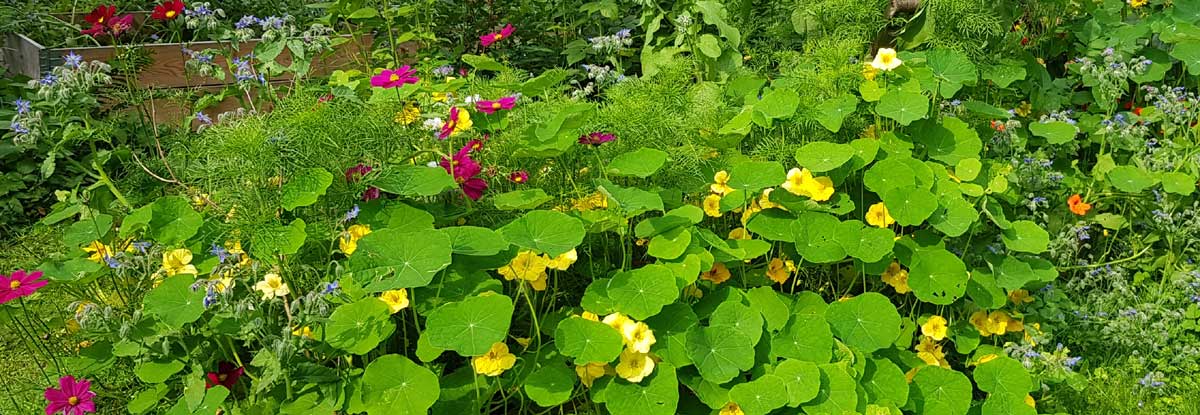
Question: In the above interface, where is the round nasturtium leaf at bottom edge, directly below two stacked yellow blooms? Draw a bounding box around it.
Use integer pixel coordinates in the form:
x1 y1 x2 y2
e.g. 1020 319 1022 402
910 366 972 415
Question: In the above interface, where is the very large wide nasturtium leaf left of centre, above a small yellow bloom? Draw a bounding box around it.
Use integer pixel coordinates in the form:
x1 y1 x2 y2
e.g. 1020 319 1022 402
348 228 454 293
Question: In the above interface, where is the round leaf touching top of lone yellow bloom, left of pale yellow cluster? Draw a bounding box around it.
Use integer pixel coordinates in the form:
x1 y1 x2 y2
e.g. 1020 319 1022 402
424 294 514 356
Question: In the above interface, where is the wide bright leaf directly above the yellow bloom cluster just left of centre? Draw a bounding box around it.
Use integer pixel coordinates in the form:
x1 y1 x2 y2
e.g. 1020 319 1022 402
496 210 583 257
